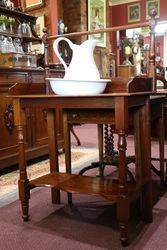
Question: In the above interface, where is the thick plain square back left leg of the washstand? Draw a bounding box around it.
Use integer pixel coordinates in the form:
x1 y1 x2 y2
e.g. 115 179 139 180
47 109 60 204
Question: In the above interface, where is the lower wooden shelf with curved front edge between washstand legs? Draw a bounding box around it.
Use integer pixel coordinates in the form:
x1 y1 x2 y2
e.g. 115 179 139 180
29 172 140 201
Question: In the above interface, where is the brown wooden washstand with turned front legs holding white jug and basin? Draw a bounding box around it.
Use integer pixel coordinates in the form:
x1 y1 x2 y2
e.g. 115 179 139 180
10 8 166 245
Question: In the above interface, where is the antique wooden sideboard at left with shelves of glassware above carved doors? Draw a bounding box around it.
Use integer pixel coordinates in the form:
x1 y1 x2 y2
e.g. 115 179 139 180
0 6 48 169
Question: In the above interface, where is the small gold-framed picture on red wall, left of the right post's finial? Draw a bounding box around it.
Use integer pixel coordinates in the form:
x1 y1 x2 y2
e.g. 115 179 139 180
128 3 140 23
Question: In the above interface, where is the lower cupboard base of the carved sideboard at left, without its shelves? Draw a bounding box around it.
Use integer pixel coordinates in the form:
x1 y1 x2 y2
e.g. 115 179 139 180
0 67 66 169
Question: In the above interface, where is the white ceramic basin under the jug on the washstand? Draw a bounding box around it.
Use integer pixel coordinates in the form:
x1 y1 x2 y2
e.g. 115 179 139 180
47 78 111 95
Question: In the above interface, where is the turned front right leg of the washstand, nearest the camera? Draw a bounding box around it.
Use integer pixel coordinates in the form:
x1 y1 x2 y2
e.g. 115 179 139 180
115 97 130 246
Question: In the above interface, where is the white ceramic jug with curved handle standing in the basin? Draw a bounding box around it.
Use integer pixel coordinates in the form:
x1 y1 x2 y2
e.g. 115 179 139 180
53 37 100 81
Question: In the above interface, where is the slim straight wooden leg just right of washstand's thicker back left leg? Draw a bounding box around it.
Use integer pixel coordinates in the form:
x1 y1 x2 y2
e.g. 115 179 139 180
63 111 72 204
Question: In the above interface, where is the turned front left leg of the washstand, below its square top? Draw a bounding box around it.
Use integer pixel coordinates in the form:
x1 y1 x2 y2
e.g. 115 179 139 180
17 125 30 221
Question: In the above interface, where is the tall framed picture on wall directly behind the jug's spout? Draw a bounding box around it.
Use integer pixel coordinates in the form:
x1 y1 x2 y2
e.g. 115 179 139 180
88 0 106 47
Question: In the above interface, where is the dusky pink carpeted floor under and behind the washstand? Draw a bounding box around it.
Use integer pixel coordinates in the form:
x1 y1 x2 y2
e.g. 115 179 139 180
0 125 167 250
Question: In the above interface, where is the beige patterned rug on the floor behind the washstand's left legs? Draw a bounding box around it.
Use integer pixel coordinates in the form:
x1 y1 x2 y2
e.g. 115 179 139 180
0 147 98 205
